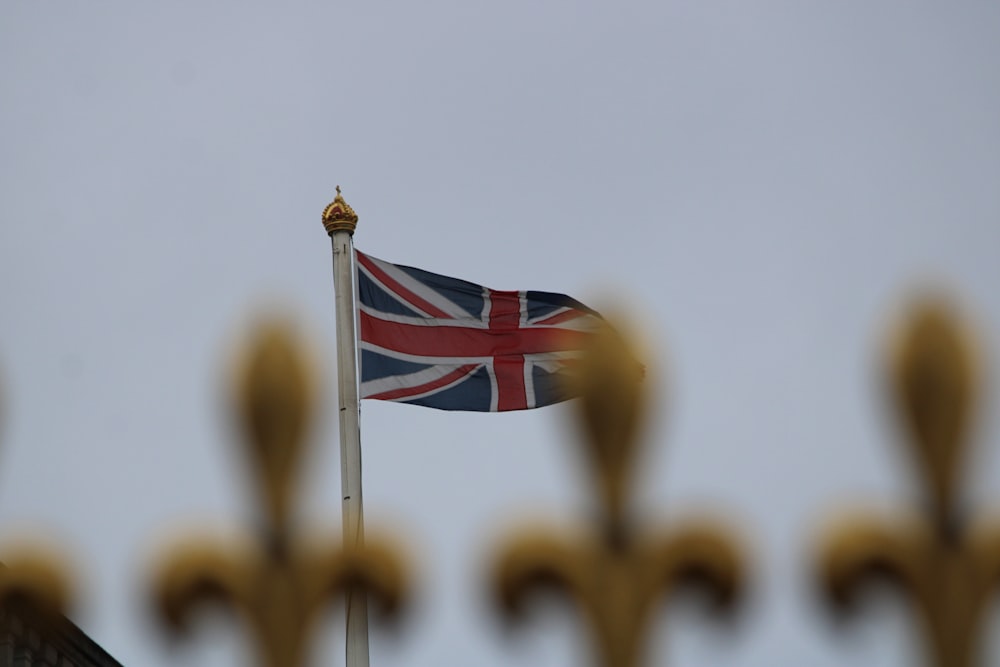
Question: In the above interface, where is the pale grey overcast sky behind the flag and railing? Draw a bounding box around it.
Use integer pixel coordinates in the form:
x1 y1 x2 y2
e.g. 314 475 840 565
0 0 1000 667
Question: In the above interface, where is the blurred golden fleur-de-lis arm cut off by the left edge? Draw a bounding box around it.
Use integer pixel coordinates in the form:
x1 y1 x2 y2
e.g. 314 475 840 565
0 384 72 623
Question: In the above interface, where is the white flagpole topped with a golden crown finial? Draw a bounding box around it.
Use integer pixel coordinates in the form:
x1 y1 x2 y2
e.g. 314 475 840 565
323 185 368 667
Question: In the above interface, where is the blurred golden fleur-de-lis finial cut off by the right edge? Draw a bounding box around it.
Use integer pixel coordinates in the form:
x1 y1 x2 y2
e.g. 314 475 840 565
818 299 1000 667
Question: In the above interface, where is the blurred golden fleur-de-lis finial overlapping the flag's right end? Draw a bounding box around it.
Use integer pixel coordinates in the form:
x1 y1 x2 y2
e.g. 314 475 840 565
492 318 745 667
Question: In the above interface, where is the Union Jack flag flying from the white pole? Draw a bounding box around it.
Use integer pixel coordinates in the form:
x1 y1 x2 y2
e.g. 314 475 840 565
355 251 600 412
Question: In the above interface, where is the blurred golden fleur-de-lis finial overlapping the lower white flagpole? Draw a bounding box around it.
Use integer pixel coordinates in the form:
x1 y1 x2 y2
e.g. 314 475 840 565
153 322 408 667
